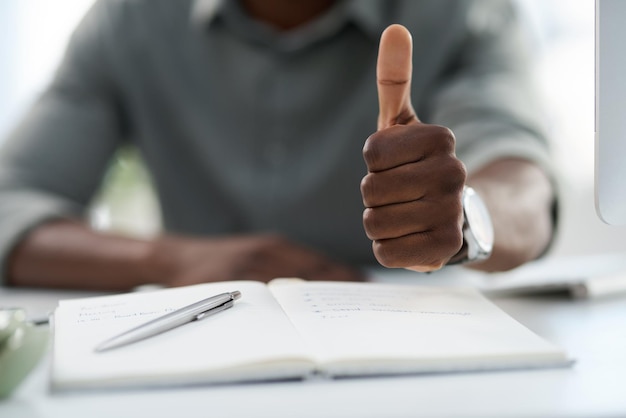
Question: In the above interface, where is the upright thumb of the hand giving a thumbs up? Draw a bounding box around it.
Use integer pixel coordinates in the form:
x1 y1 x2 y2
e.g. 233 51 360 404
376 25 419 130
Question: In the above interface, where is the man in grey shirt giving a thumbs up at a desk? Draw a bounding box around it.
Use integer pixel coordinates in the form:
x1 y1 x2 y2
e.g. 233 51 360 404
0 0 555 290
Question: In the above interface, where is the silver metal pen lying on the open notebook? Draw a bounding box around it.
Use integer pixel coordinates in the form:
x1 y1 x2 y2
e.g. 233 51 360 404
95 290 241 352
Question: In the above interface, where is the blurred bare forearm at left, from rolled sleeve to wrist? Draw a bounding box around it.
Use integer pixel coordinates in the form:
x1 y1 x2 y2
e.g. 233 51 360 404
7 221 159 291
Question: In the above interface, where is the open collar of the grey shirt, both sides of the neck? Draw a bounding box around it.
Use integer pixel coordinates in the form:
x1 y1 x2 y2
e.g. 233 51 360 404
190 0 387 41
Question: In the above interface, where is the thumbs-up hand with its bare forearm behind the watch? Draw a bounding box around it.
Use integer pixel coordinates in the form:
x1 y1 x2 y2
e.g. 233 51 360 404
361 25 553 271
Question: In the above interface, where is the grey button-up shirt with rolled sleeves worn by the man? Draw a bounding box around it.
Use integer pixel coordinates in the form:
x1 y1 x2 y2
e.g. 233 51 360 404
0 0 550 280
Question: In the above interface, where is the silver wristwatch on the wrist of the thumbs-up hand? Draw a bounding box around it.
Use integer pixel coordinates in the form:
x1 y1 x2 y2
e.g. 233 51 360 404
448 186 493 264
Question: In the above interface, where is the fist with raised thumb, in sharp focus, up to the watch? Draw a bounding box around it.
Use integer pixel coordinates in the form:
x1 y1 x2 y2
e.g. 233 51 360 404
361 25 466 271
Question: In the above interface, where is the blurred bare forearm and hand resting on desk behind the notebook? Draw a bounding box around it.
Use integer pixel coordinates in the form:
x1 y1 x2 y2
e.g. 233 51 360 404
8 221 364 291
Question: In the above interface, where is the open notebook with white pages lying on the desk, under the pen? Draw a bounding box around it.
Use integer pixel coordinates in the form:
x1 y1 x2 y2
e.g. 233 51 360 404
51 279 571 389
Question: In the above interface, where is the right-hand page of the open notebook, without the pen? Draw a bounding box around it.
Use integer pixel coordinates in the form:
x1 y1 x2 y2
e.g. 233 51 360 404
270 280 566 374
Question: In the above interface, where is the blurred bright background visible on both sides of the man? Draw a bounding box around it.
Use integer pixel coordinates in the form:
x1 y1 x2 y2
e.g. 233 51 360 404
0 0 626 255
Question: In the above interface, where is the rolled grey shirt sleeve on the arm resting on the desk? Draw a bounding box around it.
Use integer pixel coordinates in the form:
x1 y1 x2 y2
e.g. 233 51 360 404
0 1 124 282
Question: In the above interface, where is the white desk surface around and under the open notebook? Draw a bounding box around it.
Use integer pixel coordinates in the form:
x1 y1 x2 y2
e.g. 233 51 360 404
0 270 626 418
